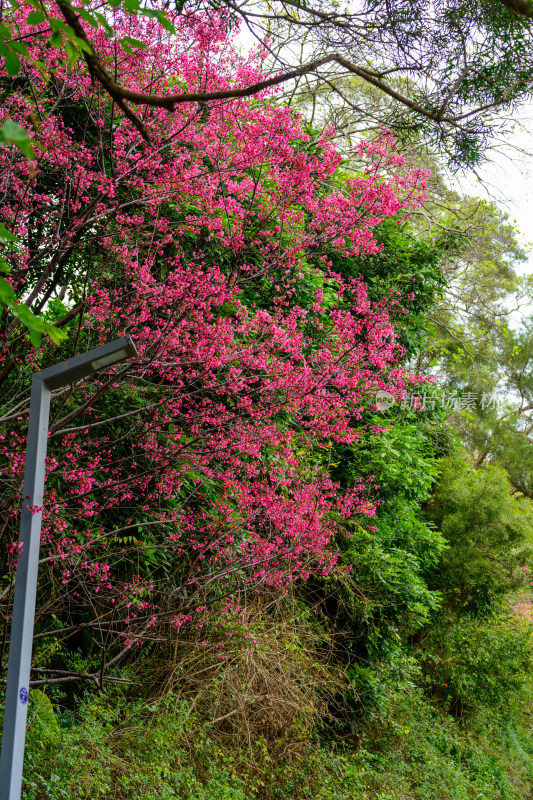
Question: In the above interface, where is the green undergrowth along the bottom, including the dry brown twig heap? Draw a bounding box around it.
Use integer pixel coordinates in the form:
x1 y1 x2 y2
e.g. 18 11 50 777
23 610 533 800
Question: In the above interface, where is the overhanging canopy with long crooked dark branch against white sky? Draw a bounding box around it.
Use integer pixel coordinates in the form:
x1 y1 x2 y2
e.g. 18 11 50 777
1 0 533 165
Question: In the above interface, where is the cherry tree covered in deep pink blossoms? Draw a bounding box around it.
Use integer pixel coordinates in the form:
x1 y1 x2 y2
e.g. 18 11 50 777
0 5 425 681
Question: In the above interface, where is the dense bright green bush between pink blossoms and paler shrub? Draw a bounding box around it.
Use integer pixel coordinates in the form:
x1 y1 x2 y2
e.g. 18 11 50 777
301 412 444 724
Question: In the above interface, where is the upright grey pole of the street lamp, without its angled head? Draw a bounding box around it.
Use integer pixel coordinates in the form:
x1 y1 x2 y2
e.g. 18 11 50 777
0 373 50 800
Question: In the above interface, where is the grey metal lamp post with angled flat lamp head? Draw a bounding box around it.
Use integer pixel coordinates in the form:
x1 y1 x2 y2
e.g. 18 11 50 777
0 336 137 800
